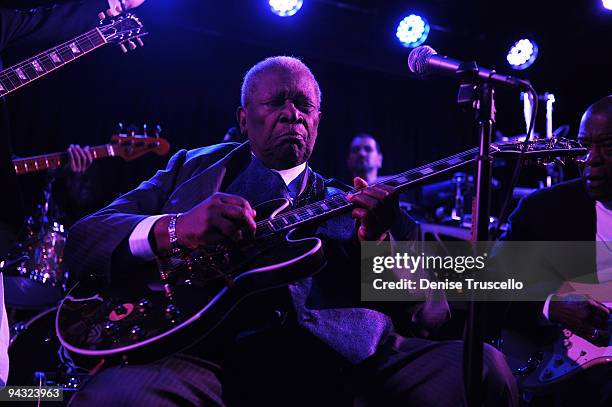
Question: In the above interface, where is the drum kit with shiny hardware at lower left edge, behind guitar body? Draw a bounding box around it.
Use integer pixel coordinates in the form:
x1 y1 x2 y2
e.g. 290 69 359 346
0 180 86 390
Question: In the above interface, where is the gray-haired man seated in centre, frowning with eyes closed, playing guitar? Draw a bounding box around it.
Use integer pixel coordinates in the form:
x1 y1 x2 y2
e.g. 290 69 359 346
66 57 516 406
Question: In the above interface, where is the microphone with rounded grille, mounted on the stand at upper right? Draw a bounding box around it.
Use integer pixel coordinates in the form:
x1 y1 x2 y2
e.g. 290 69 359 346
408 45 531 89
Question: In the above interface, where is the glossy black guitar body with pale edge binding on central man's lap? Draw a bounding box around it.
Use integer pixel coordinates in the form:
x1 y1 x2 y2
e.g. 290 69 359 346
56 200 325 368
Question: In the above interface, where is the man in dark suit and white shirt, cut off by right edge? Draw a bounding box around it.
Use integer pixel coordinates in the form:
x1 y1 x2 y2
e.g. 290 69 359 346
503 96 612 406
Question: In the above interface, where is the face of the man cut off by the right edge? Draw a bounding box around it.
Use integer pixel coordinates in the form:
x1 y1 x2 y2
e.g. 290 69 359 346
578 112 612 202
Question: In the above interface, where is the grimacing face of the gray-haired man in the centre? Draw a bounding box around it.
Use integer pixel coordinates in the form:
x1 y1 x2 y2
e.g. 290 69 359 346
238 68 321 170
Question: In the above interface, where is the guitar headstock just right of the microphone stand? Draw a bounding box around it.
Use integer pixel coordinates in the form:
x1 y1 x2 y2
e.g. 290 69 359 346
491 137 587 163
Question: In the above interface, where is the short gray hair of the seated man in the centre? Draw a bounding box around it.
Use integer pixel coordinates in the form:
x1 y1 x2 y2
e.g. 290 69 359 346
240 56 321 108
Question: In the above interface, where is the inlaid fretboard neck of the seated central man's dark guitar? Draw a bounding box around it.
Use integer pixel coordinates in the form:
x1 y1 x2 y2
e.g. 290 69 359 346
256 148 480 238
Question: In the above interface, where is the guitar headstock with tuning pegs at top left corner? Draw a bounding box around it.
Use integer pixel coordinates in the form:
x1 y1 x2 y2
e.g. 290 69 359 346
98 13 148 52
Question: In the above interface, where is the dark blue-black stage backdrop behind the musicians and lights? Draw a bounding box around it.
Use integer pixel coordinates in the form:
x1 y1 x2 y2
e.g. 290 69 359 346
4 0 612 220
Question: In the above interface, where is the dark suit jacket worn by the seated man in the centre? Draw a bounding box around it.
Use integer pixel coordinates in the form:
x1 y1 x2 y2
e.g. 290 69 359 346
65 143 447 363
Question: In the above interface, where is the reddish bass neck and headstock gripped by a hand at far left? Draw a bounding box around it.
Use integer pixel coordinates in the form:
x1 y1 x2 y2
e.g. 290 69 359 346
13 134 170 175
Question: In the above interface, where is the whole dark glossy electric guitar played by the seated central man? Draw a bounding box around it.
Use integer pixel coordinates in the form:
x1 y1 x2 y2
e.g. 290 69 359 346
56 139 586 366
